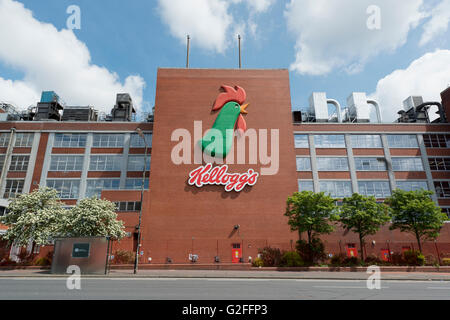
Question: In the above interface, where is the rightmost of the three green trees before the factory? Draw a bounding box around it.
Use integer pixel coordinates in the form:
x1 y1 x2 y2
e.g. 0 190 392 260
386 189 447 252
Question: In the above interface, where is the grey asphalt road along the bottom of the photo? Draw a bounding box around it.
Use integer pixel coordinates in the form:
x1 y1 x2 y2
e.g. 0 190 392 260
0 278 450 301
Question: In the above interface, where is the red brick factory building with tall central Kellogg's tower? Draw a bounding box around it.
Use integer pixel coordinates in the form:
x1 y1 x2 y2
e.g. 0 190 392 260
0 69 450 263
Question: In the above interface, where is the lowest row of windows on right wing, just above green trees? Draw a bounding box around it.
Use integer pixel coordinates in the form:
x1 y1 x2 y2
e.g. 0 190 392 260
298 180 428 198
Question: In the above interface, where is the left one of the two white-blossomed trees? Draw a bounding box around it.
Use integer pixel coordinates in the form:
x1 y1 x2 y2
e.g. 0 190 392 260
0 187 66 246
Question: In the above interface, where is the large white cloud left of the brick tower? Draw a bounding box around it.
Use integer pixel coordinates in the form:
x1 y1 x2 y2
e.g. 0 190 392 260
0 0 145 112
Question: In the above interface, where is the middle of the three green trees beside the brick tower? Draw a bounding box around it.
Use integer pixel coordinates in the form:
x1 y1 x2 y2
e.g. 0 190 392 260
339 193 390 261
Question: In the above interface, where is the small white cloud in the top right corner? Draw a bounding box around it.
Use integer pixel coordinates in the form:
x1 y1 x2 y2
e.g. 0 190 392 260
419 0 450 46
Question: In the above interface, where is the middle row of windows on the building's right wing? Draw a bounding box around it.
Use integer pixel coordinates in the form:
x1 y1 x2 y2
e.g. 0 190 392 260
297 157 424 171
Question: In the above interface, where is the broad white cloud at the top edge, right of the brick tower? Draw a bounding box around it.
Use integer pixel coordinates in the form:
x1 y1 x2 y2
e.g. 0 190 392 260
285 0 424 75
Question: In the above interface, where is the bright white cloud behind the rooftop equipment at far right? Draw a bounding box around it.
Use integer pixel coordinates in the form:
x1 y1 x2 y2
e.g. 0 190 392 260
371 50 450 122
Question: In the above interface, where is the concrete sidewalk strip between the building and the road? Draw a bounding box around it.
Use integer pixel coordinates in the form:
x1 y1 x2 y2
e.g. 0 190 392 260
0 270 450 281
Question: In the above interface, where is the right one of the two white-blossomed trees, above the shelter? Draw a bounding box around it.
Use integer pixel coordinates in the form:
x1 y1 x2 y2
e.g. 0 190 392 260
62 197 126 239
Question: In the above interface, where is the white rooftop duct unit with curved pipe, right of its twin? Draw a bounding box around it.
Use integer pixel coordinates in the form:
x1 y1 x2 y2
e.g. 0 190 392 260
347 92 381 123
